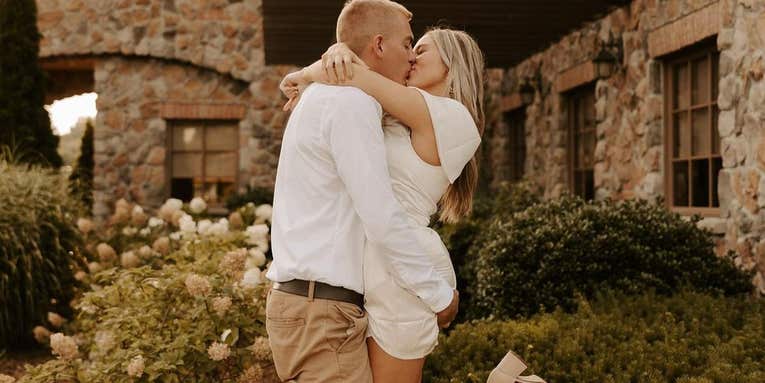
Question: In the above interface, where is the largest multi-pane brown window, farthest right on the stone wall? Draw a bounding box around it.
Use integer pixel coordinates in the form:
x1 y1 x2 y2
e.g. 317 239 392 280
665 45 722 214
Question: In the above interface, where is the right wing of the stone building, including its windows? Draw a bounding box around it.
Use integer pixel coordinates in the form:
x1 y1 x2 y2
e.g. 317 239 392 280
485 0 765 292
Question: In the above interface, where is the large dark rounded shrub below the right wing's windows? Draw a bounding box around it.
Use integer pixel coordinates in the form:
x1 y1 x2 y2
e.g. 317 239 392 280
468 196 752 318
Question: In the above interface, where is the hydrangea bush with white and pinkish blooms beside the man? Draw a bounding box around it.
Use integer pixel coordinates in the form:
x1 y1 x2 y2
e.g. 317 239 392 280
21 199 273 383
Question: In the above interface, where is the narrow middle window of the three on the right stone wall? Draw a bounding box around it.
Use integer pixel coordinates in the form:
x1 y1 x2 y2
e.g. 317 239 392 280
568 85 596 200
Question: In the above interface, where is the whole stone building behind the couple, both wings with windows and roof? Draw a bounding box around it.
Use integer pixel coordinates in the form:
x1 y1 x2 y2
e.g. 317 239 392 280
37 0 765 290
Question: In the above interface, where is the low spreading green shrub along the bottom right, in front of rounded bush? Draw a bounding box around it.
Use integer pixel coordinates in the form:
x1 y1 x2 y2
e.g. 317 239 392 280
424 292 765 383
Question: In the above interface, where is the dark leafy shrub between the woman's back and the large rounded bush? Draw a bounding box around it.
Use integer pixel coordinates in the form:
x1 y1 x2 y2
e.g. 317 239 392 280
435 181 541 323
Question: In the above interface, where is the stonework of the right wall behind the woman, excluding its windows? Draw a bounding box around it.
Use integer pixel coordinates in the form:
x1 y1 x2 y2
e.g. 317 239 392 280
484 0 765 291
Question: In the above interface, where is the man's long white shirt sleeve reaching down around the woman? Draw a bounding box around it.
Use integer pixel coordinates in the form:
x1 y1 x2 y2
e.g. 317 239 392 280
324 88 454 312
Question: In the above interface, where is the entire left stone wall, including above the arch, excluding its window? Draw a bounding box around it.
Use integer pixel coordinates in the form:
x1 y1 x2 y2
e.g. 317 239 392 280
37 0 294 218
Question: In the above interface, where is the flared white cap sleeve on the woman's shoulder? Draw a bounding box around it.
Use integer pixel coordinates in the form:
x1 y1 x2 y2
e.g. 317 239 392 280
415 88 481 183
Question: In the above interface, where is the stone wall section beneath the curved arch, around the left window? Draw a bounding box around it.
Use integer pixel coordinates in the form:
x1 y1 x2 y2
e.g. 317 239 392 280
94 57 287 216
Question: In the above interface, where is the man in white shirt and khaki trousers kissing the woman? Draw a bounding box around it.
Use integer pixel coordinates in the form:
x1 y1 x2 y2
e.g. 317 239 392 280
266 0 458 383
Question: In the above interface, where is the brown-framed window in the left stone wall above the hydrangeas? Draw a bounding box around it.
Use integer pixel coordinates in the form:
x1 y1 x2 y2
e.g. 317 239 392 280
168 121 239 208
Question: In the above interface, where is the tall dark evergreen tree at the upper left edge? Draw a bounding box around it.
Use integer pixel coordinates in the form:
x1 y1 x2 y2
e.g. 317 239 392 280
0 0 62 167
